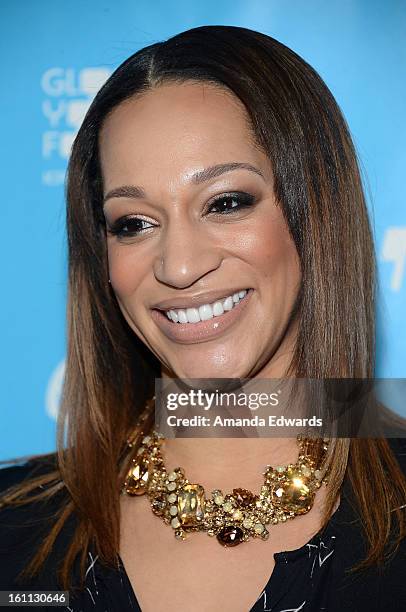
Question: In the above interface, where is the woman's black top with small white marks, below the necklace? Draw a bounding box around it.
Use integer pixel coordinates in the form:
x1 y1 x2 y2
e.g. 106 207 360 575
0 439 406 612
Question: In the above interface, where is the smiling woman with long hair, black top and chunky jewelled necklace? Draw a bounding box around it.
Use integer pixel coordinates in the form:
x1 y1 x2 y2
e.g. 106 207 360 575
0 26 406 612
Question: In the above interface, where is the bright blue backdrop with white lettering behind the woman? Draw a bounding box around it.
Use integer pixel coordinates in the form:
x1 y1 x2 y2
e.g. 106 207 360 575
0 0 406 460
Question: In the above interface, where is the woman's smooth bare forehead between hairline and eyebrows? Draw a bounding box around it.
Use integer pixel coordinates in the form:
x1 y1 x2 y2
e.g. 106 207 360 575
100 82 267 183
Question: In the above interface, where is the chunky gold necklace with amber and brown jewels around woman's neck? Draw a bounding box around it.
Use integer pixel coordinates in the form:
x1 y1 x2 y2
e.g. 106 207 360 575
122 400 329 546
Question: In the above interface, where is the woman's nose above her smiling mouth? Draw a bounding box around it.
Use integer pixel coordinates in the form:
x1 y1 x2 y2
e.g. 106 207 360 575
153 221 223 289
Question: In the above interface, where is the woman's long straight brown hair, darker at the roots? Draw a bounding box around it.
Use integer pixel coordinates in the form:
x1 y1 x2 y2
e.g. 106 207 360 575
3 26 406 588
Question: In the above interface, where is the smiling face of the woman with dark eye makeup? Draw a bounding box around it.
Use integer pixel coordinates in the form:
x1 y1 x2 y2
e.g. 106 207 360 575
100 83 300 378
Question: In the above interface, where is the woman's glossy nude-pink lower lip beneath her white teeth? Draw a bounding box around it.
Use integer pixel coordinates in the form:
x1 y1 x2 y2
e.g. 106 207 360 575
151 289 253 344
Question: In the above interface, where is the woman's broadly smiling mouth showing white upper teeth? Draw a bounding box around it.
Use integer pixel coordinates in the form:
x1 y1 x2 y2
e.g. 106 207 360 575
151 289 254 344
